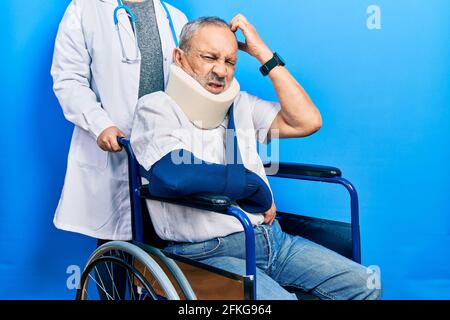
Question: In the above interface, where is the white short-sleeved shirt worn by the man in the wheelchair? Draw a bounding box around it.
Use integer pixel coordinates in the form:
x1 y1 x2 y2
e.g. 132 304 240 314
131 92 280 242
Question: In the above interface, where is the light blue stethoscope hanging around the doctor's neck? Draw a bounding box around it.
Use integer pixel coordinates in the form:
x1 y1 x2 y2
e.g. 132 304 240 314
114 0 178 64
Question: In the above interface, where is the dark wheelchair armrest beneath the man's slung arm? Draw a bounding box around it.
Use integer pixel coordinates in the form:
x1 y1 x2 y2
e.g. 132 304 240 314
139 185 231 213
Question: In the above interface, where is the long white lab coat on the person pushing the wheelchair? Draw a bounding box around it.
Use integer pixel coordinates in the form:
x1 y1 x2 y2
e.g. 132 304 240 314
51 0 187 240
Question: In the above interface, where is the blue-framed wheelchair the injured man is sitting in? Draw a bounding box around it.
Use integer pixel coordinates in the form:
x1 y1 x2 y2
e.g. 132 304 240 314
76 138 361 300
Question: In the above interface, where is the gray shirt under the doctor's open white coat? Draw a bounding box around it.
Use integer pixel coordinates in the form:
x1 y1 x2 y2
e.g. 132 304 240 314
125 0 164 98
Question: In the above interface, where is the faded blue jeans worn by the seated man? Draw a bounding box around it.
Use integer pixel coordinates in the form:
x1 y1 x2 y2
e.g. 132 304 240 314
165 220 381 300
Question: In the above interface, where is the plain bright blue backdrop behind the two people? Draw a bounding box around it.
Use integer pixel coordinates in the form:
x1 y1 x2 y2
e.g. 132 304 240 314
0 0 450 299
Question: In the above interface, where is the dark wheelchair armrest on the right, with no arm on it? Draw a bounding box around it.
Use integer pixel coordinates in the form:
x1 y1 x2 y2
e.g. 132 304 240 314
264 162 342 178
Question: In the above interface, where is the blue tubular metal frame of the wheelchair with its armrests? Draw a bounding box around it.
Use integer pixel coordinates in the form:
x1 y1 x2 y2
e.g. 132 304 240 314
77 138 361 300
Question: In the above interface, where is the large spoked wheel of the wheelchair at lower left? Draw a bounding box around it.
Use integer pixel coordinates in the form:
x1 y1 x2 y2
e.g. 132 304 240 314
77 241 180 300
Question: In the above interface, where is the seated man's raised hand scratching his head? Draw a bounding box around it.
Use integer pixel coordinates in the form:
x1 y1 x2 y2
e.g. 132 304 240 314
230 14 273 64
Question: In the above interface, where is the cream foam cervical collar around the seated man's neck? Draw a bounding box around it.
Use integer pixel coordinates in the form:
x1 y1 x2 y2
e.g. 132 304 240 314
166 64 240 129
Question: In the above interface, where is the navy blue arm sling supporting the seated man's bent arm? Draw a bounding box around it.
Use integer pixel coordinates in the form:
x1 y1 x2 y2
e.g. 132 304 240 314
140 106 273 213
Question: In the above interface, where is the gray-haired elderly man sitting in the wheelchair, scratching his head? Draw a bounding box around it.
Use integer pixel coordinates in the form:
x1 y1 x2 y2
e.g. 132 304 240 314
131 15 380 299
